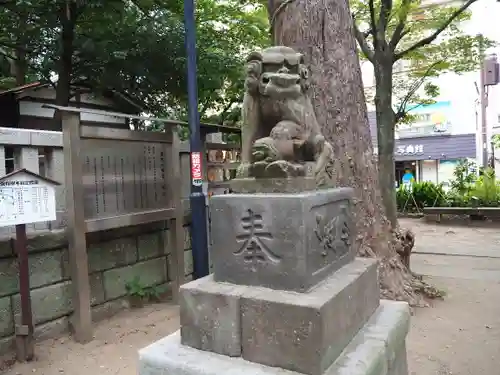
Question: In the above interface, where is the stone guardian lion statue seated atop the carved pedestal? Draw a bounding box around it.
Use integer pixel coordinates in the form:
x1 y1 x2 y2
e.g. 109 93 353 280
239 46 333 185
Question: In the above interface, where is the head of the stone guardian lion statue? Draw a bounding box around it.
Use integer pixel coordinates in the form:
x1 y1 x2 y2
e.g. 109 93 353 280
245 46 309 99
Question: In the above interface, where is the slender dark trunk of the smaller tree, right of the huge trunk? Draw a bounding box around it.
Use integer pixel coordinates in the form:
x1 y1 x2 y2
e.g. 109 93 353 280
375 61 398 228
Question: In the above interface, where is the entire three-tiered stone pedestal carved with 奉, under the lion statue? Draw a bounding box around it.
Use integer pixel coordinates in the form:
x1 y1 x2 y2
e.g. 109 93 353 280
139 189 409 375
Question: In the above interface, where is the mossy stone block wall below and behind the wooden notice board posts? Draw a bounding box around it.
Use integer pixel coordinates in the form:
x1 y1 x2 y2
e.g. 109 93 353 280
0 223 193 354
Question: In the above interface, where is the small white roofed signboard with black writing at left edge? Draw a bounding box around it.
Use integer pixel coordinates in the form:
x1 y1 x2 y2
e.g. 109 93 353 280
0 169 59 227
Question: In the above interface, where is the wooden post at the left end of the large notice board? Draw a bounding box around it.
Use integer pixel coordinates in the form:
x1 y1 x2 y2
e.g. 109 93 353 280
62 112 93 343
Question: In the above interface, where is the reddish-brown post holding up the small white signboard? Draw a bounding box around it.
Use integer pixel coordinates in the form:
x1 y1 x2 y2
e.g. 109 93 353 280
15 224 34 361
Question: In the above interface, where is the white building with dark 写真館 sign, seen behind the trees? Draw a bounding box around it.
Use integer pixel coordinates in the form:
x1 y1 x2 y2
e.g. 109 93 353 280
361 0 500 187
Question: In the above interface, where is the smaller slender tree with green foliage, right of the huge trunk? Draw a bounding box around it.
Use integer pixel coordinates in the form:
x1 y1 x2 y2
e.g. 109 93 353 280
351 0 491 225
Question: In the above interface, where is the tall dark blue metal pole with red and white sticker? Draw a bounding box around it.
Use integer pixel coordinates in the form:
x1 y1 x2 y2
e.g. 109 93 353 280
184 0 209 279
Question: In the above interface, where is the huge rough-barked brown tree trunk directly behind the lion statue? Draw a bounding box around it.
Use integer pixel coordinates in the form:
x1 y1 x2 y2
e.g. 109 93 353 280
268 0 428 304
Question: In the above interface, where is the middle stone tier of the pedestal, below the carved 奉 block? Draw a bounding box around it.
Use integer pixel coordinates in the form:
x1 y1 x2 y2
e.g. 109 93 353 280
180 258 380 375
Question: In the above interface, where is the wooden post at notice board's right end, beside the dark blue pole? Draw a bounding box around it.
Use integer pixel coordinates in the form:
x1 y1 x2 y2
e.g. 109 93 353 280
169 131 184 302
